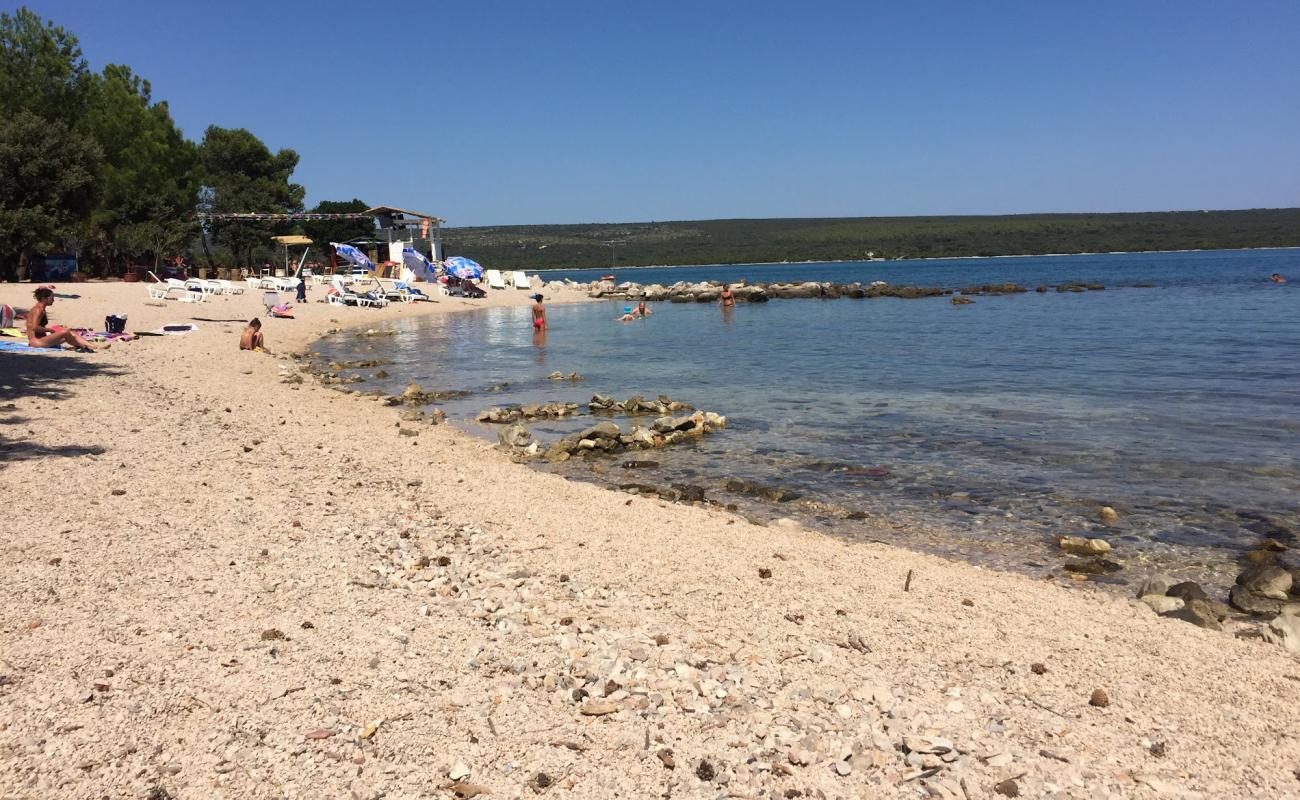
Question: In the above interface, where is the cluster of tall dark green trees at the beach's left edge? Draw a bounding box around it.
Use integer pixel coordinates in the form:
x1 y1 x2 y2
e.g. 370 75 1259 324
0 8 304 278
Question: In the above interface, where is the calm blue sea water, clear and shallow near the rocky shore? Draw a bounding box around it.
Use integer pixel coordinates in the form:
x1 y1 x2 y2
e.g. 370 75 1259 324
320 250 1300 579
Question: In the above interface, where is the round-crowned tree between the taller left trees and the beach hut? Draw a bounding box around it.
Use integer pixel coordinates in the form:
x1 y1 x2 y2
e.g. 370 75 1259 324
199 125 306 265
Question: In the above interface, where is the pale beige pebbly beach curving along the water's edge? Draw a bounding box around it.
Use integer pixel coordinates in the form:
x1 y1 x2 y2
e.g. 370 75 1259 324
0 282 1300 800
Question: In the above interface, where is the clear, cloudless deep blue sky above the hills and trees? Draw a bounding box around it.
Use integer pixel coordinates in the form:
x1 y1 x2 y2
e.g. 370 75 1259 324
20 0 1300 225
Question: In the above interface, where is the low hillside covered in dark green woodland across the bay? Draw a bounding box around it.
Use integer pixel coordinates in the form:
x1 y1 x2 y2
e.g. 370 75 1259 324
443 208 1300 271
